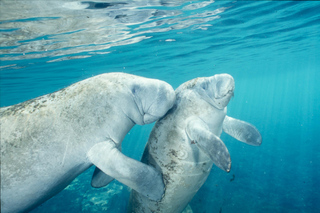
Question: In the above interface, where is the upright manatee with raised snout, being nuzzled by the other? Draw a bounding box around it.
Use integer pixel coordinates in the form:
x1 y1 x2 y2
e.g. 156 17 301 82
128 74 262 213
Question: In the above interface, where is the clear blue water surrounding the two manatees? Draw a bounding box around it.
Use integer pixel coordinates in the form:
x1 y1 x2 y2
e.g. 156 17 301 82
0 1 320 213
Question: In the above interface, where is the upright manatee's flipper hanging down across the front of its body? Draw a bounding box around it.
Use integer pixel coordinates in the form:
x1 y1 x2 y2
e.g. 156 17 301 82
186 119 231 172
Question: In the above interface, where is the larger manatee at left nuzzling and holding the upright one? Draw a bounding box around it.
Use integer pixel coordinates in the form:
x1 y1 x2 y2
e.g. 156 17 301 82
0 73 175 213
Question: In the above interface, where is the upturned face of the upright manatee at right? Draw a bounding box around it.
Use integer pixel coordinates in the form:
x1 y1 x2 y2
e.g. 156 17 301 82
195 74 235 109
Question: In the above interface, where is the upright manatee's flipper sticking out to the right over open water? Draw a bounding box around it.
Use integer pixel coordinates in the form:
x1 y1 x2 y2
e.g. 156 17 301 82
222 116 262 146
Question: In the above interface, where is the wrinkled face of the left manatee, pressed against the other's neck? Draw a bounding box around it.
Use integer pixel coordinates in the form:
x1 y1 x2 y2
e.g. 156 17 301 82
131 79 176 125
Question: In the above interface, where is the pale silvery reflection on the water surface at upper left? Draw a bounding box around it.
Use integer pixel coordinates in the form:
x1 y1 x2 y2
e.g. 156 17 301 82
0 1 226 62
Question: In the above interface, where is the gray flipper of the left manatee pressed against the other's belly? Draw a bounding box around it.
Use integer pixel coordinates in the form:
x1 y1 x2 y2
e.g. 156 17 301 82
87 140 164 200
